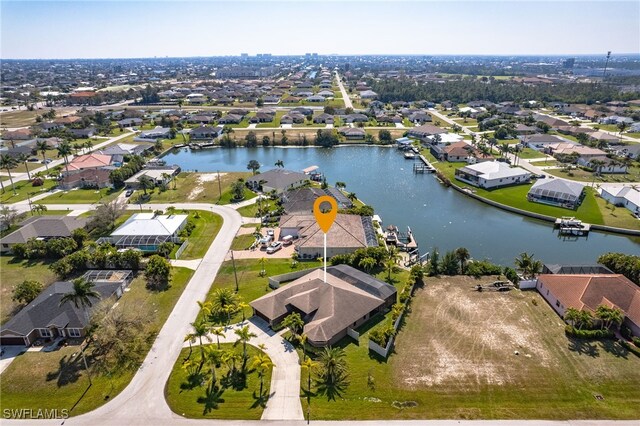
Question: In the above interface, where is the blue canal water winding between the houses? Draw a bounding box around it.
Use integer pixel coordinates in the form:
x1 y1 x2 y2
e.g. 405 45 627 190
164 146 640 265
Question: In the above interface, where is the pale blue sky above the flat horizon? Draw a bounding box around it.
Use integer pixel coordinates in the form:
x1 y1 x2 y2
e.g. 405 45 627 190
0 0 640 58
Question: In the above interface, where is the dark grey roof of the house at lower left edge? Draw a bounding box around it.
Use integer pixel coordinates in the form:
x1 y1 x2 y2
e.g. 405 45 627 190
0 281 122 336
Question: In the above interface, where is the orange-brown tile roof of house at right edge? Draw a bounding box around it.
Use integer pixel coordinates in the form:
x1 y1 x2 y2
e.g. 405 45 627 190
536 274 640 336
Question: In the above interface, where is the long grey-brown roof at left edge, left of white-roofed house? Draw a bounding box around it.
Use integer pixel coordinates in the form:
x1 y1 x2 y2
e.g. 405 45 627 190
0 216 89 244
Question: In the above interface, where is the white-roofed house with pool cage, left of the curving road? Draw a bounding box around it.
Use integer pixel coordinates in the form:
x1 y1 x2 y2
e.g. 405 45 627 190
97 213 189 253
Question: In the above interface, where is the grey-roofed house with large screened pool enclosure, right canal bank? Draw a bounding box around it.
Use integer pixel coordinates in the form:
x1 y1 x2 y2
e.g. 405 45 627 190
527 178 585 209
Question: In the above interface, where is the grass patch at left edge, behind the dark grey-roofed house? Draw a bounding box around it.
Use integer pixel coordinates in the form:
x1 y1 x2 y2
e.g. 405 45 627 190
0 256 56 324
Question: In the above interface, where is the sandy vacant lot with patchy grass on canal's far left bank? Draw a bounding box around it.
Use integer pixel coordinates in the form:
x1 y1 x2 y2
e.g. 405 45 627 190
140 172 255 204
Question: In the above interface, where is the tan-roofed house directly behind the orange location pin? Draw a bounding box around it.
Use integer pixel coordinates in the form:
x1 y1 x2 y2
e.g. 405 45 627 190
280 213 378 259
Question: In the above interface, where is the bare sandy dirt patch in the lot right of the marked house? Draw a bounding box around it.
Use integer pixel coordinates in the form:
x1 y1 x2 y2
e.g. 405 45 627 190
396 277 552 390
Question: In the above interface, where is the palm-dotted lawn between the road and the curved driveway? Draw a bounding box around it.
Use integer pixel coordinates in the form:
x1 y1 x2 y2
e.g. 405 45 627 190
165 343 271 420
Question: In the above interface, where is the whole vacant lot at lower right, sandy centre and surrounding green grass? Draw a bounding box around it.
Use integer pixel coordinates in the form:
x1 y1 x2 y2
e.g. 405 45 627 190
303 277 640 420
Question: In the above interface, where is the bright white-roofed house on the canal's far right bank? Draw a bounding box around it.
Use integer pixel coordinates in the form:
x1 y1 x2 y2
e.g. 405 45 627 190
455 161 531 189
